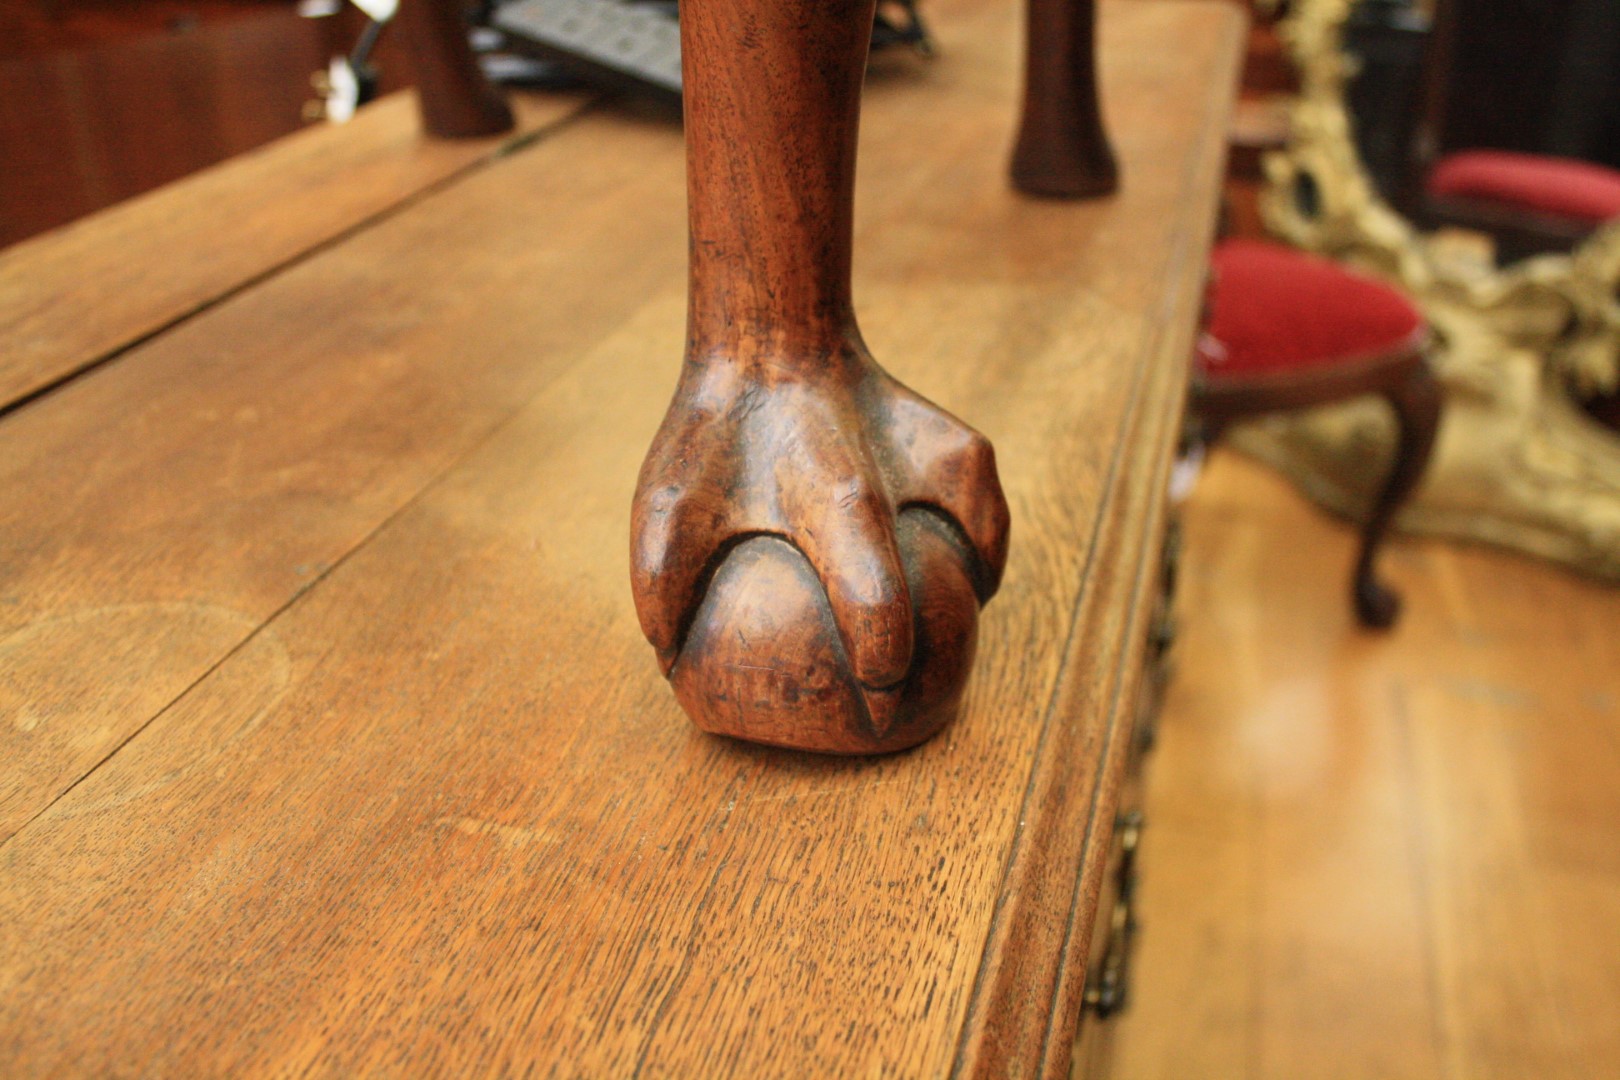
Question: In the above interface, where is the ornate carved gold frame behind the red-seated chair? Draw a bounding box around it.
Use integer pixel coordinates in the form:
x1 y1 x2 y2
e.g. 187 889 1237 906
1233 0 1620 580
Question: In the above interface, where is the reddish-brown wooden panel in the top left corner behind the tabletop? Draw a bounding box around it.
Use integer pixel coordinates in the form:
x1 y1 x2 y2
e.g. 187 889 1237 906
0 7 359 247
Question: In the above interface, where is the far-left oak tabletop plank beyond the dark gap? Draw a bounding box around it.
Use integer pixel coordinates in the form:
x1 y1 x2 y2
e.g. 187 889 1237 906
0 85 586 408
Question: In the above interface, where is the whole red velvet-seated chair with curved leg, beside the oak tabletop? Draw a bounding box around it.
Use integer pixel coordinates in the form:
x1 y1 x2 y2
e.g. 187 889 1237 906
1192 240 1440 628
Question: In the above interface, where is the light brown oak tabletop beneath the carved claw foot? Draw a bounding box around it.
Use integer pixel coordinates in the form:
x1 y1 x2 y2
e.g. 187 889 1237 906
0 0 1241 1077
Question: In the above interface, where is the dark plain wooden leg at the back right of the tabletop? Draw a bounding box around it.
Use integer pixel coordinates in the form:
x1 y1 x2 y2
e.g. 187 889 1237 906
1013 0 1119 199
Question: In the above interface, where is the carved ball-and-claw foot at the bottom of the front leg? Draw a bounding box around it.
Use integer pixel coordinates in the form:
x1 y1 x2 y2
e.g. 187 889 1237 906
632 334 1008 753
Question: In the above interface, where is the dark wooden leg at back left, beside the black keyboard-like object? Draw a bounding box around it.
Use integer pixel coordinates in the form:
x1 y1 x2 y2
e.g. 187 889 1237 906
397 0 512 139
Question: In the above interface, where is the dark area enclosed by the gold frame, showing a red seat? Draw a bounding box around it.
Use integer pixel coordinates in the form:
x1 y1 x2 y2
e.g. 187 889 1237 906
1343 0 1620 266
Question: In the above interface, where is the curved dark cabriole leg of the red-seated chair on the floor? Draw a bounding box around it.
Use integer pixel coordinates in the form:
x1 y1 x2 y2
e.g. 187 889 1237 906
1351 361 1440 630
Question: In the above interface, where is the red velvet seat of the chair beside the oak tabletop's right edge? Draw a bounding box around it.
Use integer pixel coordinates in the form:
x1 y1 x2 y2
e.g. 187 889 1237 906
1197 240 1424 381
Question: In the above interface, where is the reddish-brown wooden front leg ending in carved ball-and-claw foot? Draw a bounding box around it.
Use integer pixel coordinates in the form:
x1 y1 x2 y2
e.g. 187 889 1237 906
632 0 1008 753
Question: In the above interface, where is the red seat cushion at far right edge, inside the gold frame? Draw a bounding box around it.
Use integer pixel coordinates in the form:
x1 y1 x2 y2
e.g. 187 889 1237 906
1427 151 1620 225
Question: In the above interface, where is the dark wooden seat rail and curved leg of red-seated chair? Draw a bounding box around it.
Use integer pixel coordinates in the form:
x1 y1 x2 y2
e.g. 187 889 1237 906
1192 329 1440 630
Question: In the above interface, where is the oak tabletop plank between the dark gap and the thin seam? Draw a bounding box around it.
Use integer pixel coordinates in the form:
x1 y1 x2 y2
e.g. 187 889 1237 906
0 105 682 836
